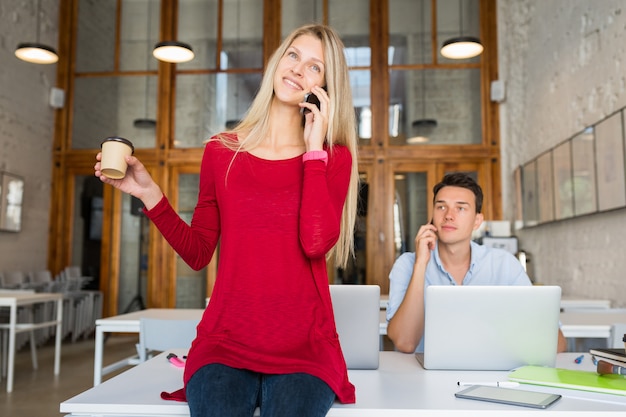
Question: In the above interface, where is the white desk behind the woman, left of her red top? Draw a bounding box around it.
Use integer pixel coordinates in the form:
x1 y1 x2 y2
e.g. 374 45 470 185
93 308 204 386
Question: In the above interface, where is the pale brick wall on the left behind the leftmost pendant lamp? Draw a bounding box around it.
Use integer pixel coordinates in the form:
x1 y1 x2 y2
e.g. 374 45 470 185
0 0 58 270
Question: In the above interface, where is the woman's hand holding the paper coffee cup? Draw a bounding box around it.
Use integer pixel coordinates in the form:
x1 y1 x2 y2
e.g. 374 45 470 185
94 152 163 210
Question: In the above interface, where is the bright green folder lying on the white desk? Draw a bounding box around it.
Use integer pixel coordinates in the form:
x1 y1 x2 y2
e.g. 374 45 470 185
509 366 626 395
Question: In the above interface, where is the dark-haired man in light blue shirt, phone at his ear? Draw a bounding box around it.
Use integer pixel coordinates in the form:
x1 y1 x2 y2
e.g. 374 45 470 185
387 172 567 353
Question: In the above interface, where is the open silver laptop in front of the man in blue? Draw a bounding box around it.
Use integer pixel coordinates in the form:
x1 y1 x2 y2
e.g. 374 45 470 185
416 285 561 370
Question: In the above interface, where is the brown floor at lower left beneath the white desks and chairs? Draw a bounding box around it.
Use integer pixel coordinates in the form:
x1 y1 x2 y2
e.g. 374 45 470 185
0 334 138 417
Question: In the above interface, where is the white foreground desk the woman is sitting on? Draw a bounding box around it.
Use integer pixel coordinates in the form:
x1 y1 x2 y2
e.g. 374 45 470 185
60 349 626 417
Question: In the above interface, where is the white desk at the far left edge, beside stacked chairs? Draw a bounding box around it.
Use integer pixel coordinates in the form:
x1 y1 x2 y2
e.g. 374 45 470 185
0 291 63 392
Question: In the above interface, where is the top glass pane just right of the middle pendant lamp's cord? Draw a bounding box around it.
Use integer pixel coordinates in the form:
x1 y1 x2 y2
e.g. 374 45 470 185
176 0 218 70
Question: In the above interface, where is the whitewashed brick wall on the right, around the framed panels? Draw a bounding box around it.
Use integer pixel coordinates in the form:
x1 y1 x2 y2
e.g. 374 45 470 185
498 0 626 307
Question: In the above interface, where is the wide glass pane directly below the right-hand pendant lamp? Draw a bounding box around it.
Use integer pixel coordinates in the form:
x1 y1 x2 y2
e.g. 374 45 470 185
389 69 482 145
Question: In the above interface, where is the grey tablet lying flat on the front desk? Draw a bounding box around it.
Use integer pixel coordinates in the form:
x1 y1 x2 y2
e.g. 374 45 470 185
454 385 561 408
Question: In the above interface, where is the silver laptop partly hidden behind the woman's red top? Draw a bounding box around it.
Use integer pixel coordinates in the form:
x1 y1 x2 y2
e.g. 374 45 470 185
330 284 380 369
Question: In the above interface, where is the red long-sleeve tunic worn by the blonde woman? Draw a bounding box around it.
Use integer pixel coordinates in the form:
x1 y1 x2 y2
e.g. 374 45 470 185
146 139 355 403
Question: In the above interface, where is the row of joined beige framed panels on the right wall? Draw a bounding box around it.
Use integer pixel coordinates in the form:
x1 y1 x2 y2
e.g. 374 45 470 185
515 103 626 227
